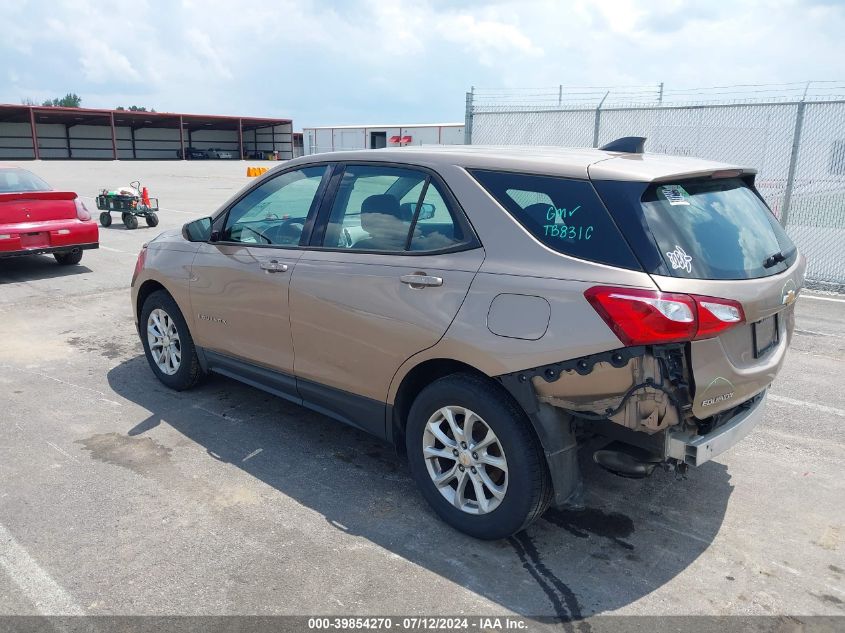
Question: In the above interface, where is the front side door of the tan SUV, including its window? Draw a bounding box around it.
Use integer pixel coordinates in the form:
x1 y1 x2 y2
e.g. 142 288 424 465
190 165 328 386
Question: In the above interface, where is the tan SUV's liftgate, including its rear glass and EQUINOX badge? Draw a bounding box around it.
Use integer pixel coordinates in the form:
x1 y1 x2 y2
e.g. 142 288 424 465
597 177 805 418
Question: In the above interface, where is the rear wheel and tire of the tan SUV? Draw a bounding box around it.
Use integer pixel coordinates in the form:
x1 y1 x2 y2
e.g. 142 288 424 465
405 374 553 540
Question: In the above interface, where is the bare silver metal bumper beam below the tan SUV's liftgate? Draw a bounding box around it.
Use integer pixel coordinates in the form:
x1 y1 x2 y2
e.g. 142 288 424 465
666 392 766 466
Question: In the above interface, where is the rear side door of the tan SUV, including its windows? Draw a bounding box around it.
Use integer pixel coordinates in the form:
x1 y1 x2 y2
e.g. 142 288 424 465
290 165 484 435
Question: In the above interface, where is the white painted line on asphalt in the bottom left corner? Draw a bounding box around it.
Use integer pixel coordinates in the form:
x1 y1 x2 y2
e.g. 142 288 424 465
0 524 85 615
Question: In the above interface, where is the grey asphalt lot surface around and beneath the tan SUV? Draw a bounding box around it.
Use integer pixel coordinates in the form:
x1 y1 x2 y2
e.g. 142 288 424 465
0 161 845 616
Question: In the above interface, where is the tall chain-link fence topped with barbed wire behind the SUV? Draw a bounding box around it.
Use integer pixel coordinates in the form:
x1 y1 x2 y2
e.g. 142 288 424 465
465 82 845 292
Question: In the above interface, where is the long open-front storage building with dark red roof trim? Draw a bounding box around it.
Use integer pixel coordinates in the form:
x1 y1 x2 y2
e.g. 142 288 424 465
0 105 293 160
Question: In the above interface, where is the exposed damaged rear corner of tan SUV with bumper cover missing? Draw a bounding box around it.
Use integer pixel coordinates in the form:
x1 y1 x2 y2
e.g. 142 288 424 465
499 345 766 498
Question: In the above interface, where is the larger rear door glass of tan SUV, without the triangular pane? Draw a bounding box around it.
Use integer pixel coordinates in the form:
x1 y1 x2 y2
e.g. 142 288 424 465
323 165 427 252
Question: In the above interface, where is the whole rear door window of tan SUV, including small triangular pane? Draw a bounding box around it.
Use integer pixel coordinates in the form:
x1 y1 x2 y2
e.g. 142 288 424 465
323 165 466 253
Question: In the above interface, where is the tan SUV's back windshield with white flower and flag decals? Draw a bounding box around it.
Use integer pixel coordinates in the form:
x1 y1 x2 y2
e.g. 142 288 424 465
642 178 796 279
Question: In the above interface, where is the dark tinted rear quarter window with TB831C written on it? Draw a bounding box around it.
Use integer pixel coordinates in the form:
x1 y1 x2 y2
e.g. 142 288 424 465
470 170 641 270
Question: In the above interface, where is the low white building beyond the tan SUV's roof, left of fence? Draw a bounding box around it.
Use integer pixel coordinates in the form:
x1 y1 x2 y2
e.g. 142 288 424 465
302 123 464 154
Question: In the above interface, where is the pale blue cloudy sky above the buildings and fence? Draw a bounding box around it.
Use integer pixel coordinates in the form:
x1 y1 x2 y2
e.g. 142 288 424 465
0 0 845 129
